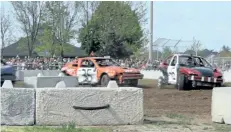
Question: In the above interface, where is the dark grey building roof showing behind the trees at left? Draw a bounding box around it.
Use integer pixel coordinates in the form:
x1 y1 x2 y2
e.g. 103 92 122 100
1 39 86 58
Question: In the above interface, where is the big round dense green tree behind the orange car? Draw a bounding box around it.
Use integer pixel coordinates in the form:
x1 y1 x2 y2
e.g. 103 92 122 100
78 1 143 58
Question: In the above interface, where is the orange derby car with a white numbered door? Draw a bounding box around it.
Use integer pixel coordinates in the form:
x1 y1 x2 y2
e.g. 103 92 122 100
61 57 143 87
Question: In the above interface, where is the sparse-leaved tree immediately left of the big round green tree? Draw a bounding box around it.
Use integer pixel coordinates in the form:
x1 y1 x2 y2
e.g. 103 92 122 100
41 1 80 56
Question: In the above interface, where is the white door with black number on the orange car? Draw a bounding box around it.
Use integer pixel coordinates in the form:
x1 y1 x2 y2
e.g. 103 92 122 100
77 59 98 84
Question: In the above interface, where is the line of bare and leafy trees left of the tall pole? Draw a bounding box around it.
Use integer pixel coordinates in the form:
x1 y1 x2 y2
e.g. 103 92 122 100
1 1 146 58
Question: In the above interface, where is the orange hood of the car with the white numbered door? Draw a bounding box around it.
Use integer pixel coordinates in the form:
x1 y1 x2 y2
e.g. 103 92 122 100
104 66 140 73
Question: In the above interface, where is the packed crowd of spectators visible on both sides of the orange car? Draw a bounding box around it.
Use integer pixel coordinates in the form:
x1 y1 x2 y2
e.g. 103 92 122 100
3 57 161 70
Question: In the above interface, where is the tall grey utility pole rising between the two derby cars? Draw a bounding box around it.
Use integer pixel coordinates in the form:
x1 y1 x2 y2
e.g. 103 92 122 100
149 1 152 62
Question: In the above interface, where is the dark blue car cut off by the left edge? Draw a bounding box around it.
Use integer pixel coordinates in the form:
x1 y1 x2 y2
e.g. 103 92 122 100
1 60 16 86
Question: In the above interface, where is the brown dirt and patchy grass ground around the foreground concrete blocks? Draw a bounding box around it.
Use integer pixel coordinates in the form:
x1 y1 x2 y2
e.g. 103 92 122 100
2 79 231 132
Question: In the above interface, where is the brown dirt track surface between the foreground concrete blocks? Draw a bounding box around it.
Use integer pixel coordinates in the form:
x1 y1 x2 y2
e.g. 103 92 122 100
139 80 212 122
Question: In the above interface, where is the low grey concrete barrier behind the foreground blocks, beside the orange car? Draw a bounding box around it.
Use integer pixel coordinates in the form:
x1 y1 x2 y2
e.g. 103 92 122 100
24 76 78 88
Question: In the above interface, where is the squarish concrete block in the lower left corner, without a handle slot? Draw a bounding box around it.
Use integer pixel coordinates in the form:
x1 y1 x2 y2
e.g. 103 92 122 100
1 88 35 125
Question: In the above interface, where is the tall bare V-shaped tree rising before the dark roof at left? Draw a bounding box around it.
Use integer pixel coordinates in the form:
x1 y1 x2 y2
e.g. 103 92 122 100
11 1 44 56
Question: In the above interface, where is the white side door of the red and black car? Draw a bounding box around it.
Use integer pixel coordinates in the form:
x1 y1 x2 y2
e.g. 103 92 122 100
168 56 177 84
